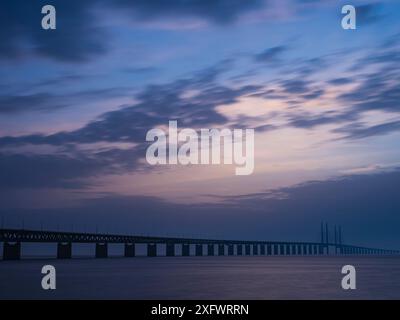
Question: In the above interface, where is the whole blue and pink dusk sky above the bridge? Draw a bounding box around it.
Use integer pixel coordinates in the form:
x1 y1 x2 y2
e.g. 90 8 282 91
0 0 400 248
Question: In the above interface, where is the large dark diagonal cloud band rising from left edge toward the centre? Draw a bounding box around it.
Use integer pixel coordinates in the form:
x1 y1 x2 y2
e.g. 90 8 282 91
0 62 259 188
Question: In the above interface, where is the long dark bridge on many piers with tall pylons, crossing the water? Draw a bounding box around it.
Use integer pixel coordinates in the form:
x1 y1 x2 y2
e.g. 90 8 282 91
0 227 400 260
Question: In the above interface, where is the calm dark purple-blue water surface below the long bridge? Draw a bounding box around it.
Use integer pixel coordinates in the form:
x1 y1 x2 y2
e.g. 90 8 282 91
0 256 400 299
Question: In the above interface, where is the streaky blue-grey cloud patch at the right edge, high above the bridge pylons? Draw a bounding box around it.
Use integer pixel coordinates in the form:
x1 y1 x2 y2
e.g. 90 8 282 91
330 35 400 139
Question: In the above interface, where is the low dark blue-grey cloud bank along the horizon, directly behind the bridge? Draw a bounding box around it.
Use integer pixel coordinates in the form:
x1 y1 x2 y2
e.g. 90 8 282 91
0 170 400 249
